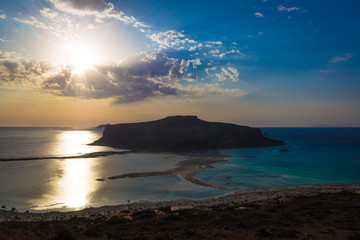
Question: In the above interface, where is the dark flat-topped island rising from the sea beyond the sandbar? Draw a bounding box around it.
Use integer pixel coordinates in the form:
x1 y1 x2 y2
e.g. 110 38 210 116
93 116 284 152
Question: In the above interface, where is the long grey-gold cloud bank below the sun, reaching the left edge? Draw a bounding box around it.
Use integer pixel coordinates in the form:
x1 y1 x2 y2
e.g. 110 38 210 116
0 52 246 104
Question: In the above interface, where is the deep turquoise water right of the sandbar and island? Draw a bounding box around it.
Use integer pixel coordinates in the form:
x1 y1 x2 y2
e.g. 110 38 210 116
195 128 360 190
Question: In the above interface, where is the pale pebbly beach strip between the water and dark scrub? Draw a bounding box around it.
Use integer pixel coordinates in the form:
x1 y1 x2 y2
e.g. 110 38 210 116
0 185 360 222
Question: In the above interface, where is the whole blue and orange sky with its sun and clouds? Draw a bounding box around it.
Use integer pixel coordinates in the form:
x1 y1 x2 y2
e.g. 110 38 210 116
0 0 360 127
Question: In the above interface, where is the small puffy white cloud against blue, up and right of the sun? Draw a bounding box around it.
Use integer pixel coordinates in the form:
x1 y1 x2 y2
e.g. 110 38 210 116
148 30 195 48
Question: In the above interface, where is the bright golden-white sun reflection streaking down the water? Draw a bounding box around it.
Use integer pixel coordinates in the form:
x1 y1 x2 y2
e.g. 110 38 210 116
32 131 105 210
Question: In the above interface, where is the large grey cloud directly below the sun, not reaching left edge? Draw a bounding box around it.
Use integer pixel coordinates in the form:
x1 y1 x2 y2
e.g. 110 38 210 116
43 52 240 104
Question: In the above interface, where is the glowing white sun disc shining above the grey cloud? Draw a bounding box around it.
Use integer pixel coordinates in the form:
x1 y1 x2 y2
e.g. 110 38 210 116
66 44 94 74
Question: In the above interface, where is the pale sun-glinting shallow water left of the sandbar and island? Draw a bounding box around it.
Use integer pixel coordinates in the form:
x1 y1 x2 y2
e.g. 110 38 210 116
0 128 221 211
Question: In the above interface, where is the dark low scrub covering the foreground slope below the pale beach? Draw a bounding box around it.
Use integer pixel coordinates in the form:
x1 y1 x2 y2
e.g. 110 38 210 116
0 191 360 240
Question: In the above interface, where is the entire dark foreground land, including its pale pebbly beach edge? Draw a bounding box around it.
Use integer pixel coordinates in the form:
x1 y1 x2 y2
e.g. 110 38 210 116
0 186 360 240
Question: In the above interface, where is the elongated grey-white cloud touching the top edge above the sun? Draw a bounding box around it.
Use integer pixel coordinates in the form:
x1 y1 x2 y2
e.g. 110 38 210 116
50 0 150 28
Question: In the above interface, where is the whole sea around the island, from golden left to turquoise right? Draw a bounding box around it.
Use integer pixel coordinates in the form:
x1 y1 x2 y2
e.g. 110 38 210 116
0 127 360 212
